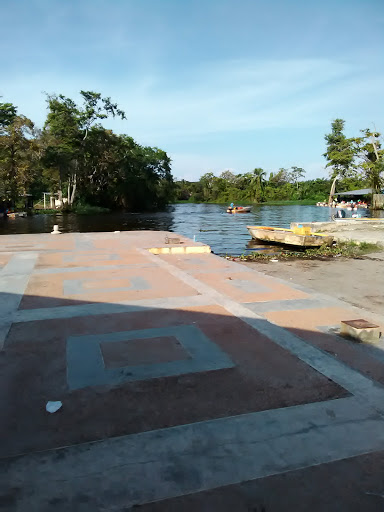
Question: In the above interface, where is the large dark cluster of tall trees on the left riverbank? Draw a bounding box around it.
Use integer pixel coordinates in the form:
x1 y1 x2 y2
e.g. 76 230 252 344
0 91 174 209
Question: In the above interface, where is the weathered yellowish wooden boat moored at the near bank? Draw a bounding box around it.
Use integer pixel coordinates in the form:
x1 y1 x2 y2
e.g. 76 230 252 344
247 226 333 247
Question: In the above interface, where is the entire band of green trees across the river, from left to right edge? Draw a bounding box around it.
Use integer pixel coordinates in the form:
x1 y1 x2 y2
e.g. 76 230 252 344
0 98 384 210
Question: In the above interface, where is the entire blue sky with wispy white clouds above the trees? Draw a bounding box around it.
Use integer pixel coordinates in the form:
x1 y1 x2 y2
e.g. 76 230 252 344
0 0 384 180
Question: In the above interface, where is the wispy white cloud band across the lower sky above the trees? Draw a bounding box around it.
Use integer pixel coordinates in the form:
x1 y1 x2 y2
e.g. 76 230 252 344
0 59 384 179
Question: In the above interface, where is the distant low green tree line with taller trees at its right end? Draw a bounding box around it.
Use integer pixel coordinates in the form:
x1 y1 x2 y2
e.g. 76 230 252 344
176 119 384 203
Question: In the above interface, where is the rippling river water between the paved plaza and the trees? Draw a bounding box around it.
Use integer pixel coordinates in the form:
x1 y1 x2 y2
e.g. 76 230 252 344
0 203 383 255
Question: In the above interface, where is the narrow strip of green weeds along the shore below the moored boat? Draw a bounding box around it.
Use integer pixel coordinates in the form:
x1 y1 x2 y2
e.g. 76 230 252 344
230 242 383 261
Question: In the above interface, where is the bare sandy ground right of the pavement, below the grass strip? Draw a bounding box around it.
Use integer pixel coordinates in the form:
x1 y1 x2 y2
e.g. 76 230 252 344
243 251 384 315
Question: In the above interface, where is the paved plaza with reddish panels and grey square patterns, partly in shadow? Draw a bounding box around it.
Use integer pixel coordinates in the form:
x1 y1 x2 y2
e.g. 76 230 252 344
0 232 384 512
